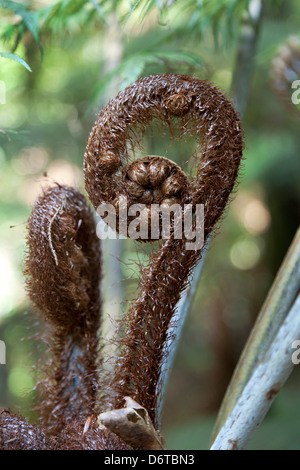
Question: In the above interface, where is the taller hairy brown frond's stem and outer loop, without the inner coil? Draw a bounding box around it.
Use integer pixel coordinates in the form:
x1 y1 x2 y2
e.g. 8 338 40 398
84 74 243 426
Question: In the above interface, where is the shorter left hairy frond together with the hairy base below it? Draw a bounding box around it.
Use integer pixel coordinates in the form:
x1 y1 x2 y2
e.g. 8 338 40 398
0 185 129 450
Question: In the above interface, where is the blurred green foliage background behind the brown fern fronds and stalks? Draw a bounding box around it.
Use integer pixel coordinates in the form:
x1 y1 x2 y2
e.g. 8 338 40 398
0 0 300 449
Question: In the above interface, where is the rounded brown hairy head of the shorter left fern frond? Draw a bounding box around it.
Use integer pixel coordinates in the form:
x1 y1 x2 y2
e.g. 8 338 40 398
25 185 101 335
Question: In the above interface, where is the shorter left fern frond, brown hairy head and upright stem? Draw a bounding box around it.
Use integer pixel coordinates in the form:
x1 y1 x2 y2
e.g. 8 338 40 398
25 185 101 432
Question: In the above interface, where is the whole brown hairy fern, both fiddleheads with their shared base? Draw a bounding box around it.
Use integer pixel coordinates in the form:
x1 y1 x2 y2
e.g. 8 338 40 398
0 74 243 450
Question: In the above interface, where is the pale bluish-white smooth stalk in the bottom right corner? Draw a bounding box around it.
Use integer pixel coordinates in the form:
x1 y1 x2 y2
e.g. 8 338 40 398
211 295 300 450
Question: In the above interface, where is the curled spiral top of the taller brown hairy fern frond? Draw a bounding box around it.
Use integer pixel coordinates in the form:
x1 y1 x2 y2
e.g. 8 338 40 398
84 74 243 242
